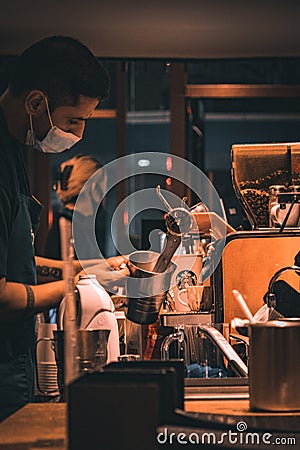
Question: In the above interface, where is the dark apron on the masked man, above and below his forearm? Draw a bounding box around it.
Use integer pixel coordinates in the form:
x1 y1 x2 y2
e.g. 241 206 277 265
0 194 42 420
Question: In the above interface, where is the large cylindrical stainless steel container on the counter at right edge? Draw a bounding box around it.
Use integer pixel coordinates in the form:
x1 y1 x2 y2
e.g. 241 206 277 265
249 318 300 411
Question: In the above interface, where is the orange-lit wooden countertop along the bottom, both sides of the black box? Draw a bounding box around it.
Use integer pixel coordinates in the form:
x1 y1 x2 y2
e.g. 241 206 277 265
0 400 300 450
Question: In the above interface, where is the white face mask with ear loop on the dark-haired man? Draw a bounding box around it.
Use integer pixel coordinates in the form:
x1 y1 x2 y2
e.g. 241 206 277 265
26 97 81 153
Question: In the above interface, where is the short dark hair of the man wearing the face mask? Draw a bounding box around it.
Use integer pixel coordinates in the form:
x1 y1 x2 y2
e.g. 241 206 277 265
9 36 109 109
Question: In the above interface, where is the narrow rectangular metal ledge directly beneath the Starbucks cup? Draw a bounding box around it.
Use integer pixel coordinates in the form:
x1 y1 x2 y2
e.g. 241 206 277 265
160 311 214 327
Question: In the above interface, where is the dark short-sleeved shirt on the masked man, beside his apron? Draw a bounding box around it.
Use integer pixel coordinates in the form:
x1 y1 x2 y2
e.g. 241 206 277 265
0 108 30 278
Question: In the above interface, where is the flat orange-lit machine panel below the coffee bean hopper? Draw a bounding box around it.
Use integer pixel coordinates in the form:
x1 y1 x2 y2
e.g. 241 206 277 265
214 228 300 323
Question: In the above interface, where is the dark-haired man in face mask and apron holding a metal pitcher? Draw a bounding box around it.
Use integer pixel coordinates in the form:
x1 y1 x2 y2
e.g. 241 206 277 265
0 36 127 420
